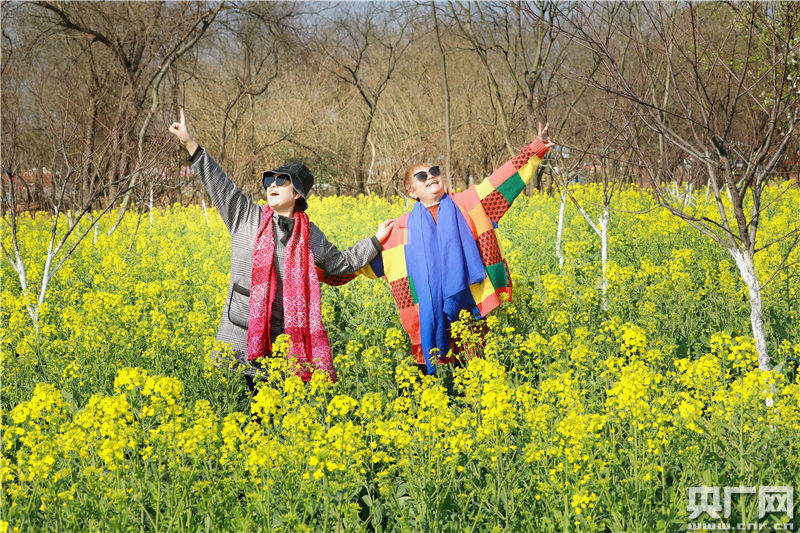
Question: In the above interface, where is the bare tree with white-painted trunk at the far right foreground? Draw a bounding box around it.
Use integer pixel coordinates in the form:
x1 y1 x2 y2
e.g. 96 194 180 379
561 3 800 370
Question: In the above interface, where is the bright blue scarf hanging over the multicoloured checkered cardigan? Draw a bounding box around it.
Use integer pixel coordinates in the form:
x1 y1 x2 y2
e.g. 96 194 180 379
404 194 486 374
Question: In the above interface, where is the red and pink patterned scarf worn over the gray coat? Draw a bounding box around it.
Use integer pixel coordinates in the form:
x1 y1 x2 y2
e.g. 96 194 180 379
247 205 336 381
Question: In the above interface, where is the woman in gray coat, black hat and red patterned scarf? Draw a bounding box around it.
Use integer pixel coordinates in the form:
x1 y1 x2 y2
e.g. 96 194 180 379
169 109 391 391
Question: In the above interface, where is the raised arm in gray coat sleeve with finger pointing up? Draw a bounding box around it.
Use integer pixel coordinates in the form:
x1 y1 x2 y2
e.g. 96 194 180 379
169 109 260 233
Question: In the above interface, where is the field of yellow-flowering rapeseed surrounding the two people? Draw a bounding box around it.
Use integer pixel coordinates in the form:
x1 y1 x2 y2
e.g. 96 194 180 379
1 186 800 533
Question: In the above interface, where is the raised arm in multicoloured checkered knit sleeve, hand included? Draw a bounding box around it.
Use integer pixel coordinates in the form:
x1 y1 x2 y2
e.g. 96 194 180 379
456 123 555 224
